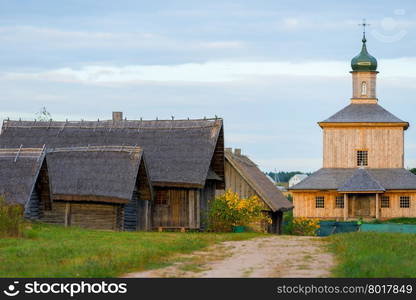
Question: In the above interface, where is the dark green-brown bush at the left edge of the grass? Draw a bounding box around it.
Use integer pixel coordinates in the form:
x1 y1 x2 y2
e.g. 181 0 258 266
0 197 23 237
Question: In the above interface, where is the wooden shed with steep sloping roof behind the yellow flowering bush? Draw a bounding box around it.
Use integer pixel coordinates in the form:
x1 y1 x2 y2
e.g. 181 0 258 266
225 148 293 234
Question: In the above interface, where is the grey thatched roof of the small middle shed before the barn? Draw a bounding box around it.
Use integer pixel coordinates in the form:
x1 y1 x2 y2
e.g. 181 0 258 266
46 146 150 202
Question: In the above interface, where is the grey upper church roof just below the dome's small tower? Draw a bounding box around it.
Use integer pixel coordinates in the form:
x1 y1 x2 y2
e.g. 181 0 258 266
320 103 409 128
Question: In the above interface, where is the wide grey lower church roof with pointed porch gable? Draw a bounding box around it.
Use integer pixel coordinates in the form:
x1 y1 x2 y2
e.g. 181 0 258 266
290 168 416 192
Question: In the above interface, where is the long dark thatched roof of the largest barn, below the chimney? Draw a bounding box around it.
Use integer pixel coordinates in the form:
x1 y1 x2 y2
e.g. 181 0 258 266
0 119 223 187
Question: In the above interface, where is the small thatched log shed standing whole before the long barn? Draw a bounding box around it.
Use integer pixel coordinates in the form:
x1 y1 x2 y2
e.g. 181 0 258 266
39 146 153 230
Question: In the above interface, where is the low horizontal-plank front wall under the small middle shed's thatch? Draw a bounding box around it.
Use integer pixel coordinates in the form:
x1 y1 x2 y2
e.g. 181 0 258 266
40 201 123 230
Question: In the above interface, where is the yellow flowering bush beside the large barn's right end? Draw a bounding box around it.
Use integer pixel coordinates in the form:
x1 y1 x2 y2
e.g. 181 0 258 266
208 190 271 232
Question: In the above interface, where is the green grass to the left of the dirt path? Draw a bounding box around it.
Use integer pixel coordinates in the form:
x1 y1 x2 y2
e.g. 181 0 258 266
0 224 259 277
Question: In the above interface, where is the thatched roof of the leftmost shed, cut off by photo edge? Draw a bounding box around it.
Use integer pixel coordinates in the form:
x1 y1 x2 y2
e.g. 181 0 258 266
0 148 45 205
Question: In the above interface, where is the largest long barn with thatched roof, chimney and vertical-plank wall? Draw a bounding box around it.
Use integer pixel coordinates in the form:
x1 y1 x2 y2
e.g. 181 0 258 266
0 116 224 230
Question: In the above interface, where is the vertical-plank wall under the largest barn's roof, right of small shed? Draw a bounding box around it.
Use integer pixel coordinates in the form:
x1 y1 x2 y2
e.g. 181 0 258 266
152 188 199 229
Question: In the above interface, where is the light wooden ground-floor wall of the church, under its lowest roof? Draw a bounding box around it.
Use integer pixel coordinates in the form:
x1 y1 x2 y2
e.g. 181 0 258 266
293 191 416 220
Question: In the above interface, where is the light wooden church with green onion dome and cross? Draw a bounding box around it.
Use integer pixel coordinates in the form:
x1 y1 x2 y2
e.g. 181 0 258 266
291 32 416 220
